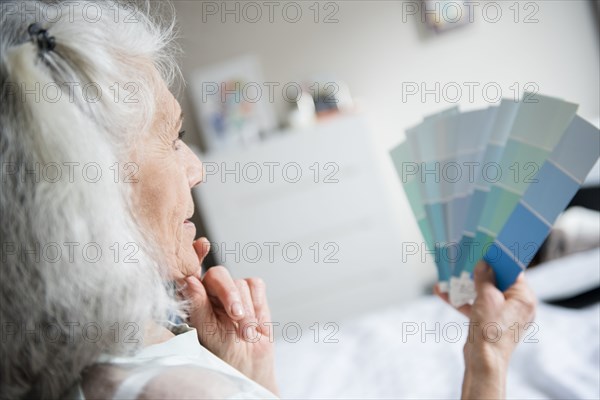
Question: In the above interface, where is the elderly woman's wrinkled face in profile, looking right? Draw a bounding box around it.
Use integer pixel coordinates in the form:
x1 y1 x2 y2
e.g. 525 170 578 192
133 74 202 279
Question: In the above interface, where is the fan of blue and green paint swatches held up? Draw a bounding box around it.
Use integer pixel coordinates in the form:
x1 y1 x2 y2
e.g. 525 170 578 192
391 93 600 306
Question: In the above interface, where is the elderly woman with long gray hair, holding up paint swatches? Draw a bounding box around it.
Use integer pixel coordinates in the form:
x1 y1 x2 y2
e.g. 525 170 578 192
0 1 534 399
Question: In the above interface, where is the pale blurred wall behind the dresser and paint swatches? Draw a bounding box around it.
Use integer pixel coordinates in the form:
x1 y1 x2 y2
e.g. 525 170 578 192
175 0 600 150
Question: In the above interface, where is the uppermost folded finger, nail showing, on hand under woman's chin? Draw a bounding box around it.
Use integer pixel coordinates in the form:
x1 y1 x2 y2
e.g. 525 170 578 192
202 266 244 321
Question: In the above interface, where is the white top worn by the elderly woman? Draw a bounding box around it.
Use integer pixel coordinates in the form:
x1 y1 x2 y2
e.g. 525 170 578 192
68 324 277 399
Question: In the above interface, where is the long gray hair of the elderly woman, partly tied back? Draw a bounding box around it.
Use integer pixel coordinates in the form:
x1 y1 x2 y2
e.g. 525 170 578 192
0 1 181 398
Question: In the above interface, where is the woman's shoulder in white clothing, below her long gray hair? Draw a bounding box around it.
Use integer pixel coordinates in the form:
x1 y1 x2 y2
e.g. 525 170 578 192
77 325 275 399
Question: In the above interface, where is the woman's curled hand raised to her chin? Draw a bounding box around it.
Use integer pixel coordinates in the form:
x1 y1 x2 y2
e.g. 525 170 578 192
182 238 277 394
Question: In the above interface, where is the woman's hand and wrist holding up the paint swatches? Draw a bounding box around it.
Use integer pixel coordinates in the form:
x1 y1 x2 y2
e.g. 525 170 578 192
435 261 536 398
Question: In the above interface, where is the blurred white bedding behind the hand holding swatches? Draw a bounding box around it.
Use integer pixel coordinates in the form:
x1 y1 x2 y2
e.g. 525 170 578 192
276 253 600 399
